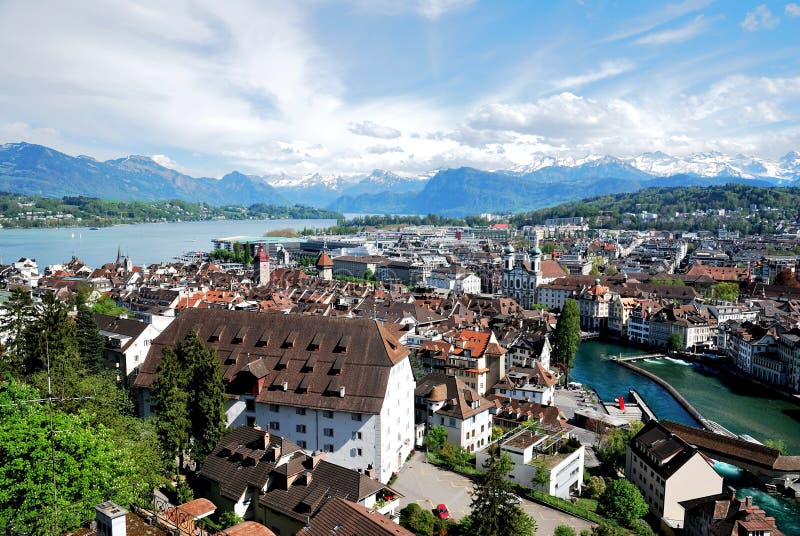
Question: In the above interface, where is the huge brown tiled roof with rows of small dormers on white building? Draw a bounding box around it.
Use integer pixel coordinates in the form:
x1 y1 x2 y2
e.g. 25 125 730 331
135 309 408 413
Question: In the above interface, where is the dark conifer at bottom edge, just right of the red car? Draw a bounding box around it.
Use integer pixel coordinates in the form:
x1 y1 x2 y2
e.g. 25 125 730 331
472 454 536 536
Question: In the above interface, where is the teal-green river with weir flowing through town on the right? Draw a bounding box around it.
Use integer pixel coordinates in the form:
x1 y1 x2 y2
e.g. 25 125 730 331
570 341 800 536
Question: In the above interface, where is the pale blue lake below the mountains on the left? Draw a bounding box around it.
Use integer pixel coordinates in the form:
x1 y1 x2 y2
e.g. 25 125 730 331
0 219 336 271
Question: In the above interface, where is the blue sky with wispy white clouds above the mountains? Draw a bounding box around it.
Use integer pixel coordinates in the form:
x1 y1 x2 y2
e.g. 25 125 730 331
0 0 800 177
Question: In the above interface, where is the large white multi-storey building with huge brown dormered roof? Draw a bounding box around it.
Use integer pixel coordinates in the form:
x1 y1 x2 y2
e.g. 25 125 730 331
134 309 416 482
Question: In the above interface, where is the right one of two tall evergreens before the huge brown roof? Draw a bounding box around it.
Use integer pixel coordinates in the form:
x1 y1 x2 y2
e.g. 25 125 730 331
182 331 227 461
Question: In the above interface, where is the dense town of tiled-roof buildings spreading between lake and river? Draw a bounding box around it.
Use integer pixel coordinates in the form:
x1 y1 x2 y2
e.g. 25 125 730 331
0 220 800 536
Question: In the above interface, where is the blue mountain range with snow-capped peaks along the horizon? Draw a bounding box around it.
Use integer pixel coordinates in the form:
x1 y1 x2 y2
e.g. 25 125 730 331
0 143 800 216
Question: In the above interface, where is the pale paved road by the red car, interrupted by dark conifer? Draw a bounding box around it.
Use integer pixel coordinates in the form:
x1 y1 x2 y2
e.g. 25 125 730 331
392 452 593 536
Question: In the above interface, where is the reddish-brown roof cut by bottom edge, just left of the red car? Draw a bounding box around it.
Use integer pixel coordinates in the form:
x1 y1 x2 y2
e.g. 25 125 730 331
296 498 414 536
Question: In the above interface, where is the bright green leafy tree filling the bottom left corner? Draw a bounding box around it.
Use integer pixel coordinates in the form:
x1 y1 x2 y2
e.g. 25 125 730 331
0 380 136 535
